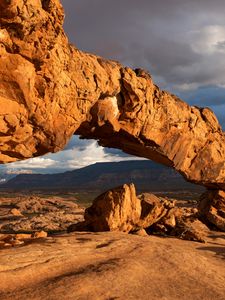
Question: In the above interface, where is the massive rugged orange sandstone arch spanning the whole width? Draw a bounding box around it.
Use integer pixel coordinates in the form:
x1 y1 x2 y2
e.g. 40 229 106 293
0 0 225 189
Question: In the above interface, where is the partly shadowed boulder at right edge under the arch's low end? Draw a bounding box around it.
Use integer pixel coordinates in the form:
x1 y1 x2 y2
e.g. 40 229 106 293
199 190 225 231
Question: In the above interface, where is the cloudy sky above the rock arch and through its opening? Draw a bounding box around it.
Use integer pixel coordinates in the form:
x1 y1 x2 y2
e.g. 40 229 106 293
1 0 225 172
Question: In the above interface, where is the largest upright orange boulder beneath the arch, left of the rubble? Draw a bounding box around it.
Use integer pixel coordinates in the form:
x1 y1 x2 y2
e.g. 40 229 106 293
84 184 141 232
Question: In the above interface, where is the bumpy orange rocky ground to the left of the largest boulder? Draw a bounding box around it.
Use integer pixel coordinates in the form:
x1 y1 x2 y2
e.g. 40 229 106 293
0 196 84 233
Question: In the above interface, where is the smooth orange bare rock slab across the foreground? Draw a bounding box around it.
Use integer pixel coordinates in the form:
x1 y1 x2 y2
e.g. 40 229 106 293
0 232 225 300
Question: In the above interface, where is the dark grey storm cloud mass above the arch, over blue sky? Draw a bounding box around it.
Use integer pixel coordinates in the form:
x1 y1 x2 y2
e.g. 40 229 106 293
63 0 225 103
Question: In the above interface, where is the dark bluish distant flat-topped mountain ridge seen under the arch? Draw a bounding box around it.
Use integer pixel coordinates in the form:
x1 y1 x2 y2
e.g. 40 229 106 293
0 160 203 191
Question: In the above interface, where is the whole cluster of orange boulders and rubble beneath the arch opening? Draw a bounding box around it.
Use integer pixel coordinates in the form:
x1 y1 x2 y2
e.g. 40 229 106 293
67 184 208 242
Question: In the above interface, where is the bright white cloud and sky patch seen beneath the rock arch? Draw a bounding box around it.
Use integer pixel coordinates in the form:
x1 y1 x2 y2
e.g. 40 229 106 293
1 136 140 173
